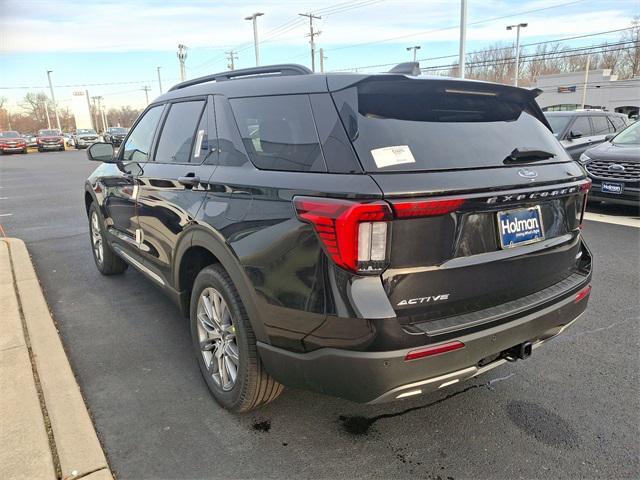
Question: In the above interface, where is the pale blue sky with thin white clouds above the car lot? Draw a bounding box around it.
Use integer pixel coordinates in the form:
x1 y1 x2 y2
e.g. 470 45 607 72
0 0 640 111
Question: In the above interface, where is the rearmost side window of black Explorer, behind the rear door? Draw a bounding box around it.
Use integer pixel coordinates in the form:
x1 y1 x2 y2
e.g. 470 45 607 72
230 95 326 172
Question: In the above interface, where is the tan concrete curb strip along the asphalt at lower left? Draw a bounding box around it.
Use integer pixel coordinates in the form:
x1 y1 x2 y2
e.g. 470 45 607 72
0 238 113 480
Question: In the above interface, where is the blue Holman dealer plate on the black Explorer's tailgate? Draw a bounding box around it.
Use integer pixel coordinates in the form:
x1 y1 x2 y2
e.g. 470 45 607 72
498 205 544 248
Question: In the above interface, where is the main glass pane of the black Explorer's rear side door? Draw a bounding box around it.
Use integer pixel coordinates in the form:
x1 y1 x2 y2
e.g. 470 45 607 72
156 100 204 163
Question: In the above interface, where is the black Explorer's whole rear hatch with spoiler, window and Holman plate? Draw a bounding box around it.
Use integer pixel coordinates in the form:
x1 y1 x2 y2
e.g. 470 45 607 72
330 76 588 331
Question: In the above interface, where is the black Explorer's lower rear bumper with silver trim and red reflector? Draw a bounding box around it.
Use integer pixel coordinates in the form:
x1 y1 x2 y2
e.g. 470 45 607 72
258 275 591 403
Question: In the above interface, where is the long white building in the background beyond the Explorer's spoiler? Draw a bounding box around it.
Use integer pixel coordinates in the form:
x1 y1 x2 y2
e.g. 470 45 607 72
532 70 640 115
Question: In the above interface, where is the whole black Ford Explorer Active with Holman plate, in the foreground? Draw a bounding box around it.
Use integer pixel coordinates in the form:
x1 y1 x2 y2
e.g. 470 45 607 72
85 65 591 411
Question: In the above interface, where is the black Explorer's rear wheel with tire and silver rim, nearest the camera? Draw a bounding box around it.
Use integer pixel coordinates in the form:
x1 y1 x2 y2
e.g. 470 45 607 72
190 264 283 412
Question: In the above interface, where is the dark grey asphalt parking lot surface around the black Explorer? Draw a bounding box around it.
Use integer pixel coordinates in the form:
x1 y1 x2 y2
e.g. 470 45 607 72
0 151 640 480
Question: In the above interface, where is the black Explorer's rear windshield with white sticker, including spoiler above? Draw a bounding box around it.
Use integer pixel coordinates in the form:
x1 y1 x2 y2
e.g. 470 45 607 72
333 77 566 172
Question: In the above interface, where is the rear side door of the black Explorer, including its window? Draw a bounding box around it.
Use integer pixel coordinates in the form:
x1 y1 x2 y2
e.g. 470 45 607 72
137 97 218 284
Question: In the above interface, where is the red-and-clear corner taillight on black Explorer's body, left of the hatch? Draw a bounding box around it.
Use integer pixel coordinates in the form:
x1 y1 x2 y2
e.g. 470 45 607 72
293 197 392 273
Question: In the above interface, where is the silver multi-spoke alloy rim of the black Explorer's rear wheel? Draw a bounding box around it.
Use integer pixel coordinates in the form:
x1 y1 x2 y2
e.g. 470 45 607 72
197 287 240 391
